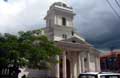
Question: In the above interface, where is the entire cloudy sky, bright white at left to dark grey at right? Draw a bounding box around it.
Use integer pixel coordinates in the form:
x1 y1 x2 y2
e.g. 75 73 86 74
0 0 120 48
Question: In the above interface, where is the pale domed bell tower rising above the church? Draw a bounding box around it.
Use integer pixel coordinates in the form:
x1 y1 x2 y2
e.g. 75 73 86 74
45 2 75 41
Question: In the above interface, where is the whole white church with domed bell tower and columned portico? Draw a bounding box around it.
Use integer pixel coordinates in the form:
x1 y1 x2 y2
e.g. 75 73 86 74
19 2 100 78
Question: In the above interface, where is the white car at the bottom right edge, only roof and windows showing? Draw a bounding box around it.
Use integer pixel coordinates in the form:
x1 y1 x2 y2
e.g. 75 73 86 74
78 72 120 78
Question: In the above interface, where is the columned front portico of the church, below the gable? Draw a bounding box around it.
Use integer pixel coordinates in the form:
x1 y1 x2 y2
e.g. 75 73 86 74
52 41 100 78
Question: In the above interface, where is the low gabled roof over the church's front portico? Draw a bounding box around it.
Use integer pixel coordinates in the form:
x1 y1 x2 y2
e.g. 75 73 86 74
56 37 100 55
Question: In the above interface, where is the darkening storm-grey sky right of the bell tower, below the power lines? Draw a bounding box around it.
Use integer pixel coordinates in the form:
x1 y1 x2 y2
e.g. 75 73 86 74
70 0 120 49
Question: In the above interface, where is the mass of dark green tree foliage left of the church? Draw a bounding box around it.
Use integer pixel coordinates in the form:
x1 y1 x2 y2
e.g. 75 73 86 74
0 30 62 69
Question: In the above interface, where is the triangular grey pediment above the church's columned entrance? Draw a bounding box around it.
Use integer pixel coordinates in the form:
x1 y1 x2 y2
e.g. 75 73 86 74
58 37 100 55
